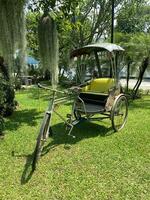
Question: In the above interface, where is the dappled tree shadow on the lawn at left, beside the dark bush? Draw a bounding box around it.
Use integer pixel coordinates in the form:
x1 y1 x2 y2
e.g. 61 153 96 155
5 109 41 131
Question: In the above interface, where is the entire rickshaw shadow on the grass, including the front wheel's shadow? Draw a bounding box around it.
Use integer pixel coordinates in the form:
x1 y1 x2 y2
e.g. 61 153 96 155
21 121 113 185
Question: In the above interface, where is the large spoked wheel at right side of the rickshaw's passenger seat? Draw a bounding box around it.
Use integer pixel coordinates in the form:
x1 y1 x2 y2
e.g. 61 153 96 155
111 94 128 131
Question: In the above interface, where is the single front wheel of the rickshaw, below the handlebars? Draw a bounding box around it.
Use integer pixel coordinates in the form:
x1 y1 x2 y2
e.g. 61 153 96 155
32 113 50 171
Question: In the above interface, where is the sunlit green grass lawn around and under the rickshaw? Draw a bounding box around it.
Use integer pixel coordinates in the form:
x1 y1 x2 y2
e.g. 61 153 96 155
0 86 150 200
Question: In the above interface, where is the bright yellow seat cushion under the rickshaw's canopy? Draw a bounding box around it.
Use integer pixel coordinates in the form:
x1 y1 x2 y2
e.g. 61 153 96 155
82 78 114 94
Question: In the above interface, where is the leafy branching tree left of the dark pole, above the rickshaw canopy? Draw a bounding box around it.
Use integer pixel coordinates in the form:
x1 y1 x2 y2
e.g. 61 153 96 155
27 0 126 78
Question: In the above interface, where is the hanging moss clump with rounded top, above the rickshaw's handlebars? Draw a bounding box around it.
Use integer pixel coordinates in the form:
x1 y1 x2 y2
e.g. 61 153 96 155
38 14 59 87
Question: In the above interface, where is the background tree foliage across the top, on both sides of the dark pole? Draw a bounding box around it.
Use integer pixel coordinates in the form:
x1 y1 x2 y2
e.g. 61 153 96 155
26 0 150 83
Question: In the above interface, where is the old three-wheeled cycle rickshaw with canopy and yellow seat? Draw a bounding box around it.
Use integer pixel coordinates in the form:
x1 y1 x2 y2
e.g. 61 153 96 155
32 43 128 170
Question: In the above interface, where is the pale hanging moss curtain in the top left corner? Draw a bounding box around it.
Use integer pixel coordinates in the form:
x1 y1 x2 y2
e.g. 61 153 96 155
0 0 26 74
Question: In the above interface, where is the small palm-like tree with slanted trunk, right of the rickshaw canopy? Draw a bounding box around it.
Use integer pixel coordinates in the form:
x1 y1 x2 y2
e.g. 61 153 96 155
115 33 150 97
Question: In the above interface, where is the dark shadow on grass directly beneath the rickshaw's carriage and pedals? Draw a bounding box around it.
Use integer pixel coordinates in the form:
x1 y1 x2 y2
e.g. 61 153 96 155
42 121 114 156
